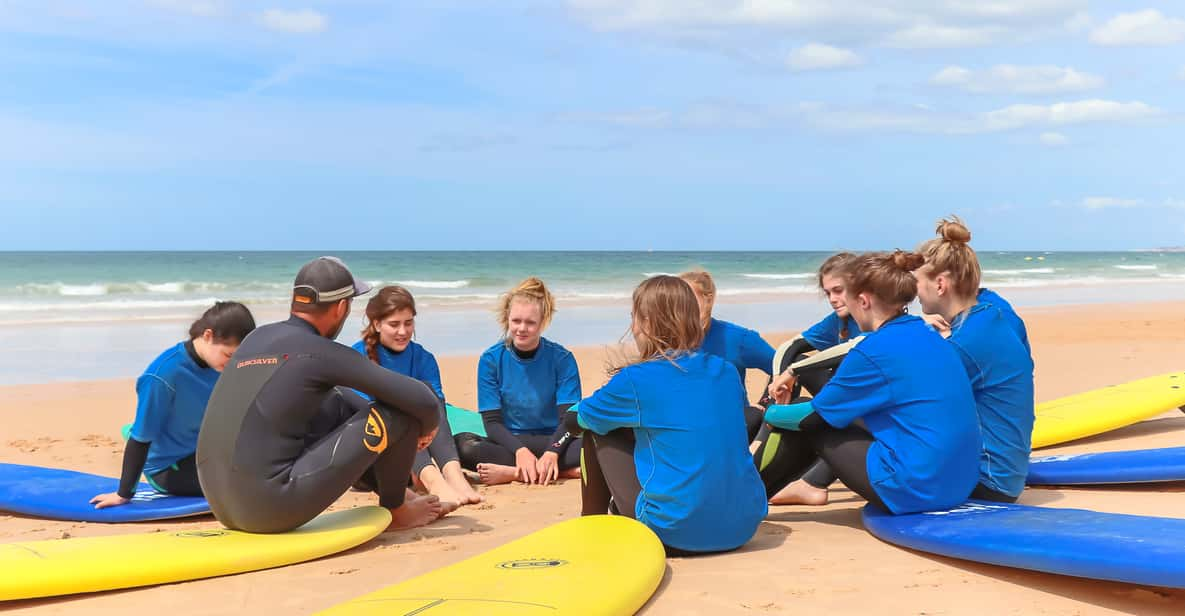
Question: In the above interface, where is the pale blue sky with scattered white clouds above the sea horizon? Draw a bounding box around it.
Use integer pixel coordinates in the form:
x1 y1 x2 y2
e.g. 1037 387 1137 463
0 0 1185 250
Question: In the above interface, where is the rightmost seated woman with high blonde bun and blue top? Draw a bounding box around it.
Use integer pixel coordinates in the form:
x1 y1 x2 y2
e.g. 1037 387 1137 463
915 218 1035 502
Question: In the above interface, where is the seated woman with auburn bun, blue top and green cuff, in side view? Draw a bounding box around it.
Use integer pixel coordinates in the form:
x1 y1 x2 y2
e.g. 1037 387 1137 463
754 251 982 514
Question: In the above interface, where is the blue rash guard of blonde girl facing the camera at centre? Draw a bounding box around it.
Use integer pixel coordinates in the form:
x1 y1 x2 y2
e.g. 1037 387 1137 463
478 338 581 435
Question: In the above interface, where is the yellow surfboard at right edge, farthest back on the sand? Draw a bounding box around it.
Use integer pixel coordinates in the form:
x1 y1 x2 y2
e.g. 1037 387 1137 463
1033 372 1185 449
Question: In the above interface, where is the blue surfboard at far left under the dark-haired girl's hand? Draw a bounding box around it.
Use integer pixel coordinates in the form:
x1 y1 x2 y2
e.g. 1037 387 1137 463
0 463 210 522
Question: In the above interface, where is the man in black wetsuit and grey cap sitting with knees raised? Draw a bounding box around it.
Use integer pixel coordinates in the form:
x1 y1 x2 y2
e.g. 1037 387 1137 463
198 257 443 533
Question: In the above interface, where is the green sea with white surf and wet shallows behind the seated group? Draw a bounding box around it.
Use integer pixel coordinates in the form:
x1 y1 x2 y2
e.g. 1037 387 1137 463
0 251 1185 384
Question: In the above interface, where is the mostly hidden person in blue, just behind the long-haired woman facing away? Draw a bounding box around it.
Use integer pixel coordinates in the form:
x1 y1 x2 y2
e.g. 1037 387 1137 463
679 270 774 441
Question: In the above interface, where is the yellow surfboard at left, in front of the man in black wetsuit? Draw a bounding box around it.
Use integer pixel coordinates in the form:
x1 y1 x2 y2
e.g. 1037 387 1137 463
0 507 391 601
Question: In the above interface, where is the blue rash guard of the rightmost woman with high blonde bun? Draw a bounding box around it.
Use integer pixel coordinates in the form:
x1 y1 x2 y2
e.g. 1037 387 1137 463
948 303 1033 496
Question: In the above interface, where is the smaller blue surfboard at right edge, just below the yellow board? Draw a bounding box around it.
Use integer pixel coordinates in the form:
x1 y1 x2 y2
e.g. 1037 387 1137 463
1025 447 1185 486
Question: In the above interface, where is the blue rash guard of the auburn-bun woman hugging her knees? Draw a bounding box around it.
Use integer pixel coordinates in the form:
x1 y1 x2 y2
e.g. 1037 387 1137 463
811 315 982 513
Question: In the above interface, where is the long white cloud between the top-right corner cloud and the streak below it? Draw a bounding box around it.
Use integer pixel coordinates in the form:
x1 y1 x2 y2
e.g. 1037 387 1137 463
930 64 1103 95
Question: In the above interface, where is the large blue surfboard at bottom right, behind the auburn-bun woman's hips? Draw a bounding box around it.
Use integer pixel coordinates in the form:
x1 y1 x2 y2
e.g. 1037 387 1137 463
864 501 1185 588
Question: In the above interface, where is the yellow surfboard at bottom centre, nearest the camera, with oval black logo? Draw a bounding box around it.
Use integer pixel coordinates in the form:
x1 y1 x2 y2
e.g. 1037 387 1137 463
321 515 666 616
